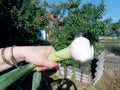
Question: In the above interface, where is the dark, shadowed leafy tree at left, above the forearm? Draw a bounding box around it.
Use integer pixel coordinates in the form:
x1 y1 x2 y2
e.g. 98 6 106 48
0 0 47 47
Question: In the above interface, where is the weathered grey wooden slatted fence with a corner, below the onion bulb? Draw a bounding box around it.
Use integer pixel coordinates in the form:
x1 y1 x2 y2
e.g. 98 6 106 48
56 50 106 85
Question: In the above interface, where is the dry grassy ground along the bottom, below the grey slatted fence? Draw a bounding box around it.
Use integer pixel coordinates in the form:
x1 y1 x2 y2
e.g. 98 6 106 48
51 71 120 90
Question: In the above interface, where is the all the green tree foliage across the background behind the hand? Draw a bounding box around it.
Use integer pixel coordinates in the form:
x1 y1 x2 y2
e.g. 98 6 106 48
0 0 120 89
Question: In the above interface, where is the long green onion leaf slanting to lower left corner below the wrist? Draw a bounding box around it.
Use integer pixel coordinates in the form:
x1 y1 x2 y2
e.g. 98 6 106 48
0 64 35 90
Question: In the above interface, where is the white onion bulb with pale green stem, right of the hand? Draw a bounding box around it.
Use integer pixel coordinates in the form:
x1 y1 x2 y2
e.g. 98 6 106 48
48 37 94 62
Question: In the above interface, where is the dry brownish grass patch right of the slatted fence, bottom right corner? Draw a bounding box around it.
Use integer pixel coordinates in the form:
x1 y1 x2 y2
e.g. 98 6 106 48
95 71 120 90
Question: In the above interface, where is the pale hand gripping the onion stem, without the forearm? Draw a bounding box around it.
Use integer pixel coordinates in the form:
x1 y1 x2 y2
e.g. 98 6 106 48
24 46 58 71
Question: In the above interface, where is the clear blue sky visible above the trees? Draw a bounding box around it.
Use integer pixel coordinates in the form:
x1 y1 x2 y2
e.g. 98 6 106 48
45 0 120 22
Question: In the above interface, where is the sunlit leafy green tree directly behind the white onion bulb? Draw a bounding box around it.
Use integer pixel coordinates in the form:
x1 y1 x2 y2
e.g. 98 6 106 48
51 0 111 64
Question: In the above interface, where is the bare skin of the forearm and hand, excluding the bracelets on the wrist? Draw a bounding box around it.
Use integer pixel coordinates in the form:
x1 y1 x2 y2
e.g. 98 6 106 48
0 46 58 72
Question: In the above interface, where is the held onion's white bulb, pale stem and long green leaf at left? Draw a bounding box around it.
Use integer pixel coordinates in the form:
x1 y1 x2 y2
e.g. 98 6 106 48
0 37 94 90
